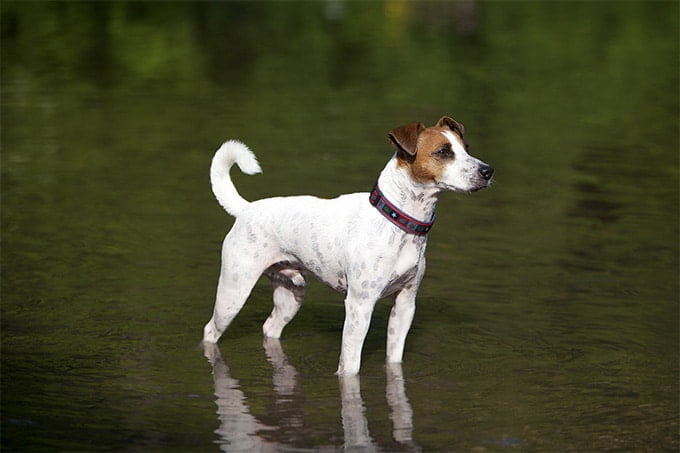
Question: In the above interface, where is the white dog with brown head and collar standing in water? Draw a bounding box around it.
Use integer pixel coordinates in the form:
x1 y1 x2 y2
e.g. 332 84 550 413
203 116 494 375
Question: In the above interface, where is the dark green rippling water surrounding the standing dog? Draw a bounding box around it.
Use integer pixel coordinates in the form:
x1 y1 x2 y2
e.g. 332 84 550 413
1 1 679 451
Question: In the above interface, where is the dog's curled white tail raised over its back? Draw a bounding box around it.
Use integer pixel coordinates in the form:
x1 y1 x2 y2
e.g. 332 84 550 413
210 140 262 217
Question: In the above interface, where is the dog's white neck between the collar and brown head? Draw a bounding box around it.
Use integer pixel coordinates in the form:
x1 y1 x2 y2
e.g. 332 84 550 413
378 154 441 222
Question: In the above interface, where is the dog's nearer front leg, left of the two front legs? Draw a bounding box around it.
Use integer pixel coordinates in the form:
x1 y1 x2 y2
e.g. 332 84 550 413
336 290 378 376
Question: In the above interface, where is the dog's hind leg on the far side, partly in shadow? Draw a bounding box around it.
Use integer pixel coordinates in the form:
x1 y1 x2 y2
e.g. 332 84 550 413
262 269 306 338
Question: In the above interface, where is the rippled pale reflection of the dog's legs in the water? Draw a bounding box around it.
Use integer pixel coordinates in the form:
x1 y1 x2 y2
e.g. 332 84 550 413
203 338 419 452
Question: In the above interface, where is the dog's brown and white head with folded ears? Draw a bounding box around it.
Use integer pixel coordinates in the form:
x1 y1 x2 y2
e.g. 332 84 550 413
388 116 493 192
